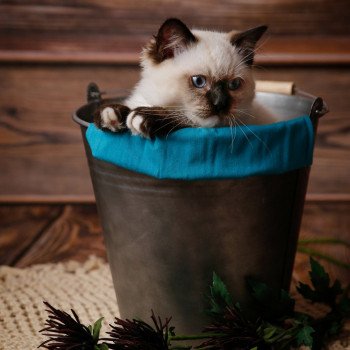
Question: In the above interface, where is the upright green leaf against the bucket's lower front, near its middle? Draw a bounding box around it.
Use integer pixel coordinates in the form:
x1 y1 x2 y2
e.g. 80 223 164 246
208 272 233 316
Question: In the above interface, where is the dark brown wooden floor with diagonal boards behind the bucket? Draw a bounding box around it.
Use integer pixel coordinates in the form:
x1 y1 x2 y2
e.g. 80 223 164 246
0 202 350 285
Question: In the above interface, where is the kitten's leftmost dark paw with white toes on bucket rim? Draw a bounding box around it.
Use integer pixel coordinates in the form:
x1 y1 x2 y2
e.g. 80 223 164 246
94 105 130 132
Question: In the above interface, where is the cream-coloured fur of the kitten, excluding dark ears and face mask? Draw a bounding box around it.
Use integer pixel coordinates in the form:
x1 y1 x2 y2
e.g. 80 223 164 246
102 26 274 134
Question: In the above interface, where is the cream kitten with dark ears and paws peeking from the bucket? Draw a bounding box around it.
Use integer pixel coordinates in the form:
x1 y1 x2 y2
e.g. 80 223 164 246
94 18 273 137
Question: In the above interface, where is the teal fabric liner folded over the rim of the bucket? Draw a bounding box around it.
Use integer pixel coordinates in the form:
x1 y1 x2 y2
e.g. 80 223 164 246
86 116 314 180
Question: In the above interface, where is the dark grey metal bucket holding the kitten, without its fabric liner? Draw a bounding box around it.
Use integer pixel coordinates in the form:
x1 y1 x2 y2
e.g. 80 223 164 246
73 89 326 332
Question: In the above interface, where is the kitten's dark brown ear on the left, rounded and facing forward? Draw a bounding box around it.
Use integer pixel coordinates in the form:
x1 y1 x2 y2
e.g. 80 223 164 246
155 18 197 62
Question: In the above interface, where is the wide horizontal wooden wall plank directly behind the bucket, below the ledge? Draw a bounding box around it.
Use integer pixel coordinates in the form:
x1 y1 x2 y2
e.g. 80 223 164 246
0 64 350 201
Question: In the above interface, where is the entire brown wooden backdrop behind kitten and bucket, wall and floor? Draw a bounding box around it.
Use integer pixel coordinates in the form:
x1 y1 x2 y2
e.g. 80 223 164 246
0 0 350 278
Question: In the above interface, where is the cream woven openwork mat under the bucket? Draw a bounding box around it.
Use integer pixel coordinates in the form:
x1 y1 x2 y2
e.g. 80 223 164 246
0 257 350 350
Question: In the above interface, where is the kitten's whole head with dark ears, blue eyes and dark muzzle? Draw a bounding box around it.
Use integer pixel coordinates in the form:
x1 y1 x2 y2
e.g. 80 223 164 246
142 19 267 127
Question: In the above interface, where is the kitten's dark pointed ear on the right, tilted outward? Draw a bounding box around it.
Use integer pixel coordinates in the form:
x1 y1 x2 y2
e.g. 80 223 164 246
230 26 267 66
